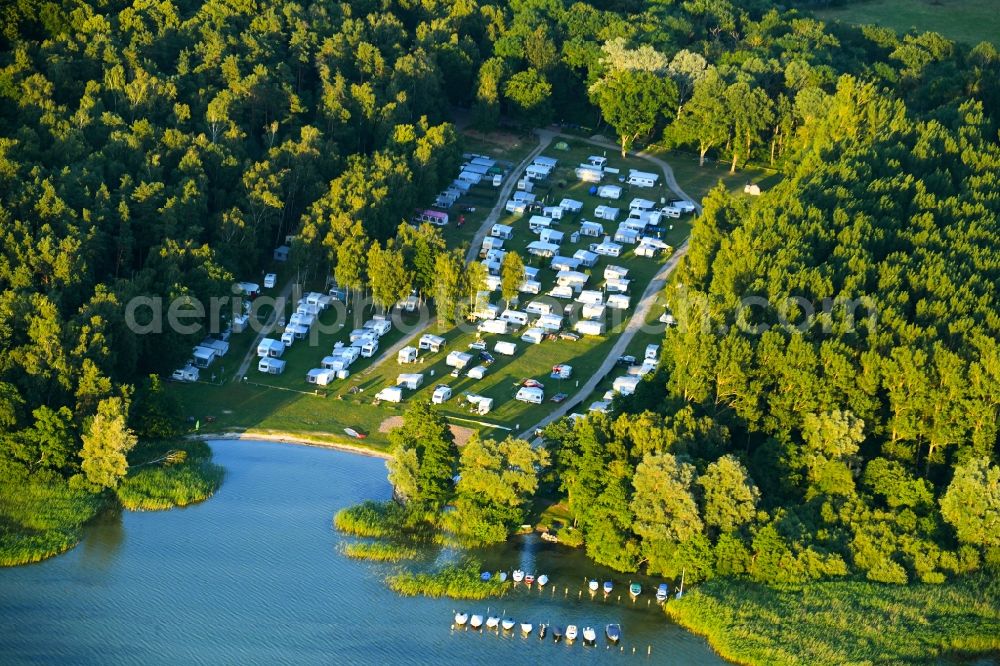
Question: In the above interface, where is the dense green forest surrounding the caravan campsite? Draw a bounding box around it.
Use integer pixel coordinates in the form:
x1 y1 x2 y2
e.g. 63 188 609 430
0 0 1000 582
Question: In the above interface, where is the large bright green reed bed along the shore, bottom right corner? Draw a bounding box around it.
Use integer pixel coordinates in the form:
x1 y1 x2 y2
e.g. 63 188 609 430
666 574 1000 664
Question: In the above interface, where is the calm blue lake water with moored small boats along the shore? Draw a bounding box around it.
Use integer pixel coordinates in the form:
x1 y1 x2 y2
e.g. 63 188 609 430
0 441 724 665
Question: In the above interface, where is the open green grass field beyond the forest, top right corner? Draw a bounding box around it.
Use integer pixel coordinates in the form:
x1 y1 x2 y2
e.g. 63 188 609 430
815 0 1000 46
